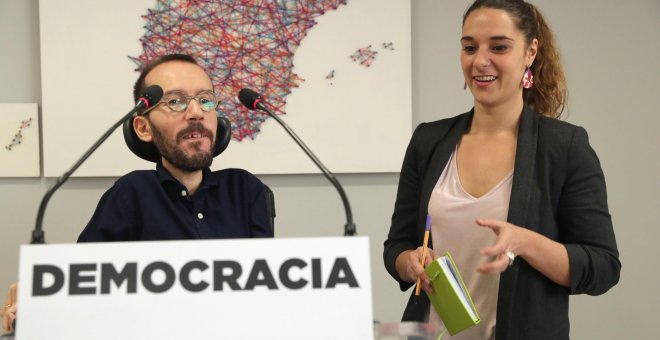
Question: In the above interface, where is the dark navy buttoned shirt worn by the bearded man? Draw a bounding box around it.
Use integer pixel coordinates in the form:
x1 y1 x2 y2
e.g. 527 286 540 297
78 164 273 242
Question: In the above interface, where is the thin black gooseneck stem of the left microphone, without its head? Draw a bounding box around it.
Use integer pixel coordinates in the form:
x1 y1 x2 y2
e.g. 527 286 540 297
30 98 155 244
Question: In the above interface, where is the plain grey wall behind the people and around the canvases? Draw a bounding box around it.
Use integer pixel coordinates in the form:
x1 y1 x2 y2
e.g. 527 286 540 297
0 0 660 339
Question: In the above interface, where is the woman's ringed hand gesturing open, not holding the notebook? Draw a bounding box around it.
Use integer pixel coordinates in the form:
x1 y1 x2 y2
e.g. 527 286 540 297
476 218 528 274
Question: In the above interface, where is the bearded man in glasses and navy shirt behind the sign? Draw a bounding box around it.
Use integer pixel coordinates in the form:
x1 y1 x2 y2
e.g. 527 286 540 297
78 54 273 242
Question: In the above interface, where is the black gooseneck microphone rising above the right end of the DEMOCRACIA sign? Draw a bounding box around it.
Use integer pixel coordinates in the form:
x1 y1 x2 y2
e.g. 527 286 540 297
238 88 357 236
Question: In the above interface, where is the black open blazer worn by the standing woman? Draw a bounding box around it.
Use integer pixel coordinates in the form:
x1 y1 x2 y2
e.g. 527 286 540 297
383 107 621 340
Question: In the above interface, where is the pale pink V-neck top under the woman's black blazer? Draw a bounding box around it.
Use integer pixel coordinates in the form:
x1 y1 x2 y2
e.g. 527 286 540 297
428 149 513 339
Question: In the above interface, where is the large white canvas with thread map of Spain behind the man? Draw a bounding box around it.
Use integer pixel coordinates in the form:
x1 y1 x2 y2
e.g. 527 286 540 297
40 0 412 176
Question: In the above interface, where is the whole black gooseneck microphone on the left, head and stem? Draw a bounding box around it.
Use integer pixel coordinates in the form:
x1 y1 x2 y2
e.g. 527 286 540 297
30 85 163 244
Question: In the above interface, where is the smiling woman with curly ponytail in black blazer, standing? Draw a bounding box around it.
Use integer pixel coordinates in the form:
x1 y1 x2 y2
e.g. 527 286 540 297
383 0 621 340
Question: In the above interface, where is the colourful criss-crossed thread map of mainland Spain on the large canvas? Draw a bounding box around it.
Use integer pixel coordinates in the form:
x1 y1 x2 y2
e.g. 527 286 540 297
131 0 346 141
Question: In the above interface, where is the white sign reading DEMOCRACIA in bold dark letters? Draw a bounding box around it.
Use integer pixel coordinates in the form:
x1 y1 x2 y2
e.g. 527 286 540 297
16 237 373 340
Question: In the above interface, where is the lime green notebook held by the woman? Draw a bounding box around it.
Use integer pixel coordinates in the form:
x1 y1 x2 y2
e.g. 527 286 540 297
425 252 481 335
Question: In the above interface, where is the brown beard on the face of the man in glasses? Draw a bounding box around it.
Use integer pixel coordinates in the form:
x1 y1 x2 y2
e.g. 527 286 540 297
151 122 215 172
